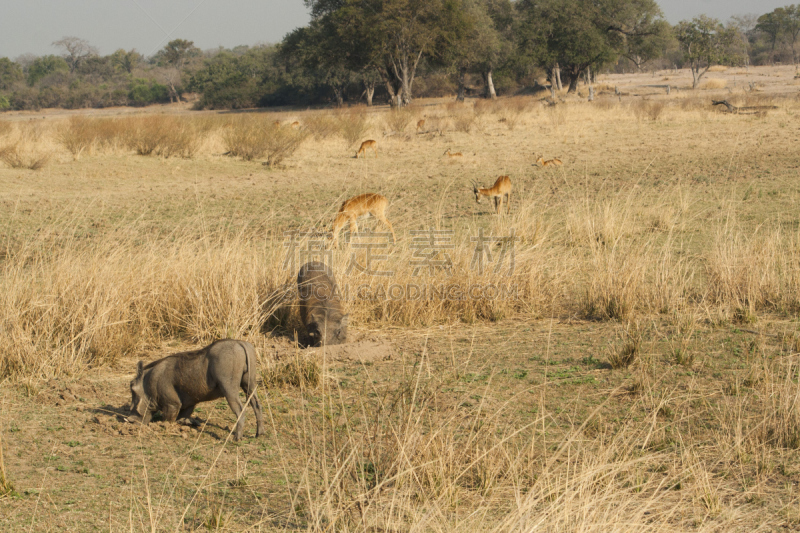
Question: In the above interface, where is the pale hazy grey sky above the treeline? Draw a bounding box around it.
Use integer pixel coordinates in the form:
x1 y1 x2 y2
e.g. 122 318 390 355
0 0 794 58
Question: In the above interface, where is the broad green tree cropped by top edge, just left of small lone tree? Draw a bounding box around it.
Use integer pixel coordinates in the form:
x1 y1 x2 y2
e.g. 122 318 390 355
517 0 663 92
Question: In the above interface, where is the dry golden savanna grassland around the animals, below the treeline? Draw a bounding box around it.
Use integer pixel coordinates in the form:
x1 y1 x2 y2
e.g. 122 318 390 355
0 67 800 532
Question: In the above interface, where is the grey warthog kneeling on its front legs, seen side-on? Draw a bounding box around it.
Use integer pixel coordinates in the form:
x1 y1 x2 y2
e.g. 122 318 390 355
128 339 264 440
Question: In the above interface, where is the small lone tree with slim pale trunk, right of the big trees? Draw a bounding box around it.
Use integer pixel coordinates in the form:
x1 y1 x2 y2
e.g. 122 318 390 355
675 15 736 89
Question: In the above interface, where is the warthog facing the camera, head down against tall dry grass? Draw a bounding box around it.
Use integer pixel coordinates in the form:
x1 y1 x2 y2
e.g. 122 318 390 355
297 261 348 346
